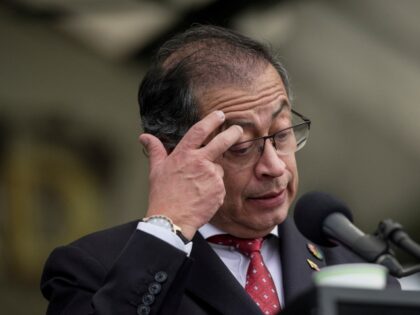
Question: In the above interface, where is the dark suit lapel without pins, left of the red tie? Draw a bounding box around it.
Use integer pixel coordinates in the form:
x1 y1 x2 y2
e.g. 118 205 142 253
187 233 261 315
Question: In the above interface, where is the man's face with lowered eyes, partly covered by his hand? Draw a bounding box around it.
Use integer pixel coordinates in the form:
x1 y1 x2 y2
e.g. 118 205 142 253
200 65 298 238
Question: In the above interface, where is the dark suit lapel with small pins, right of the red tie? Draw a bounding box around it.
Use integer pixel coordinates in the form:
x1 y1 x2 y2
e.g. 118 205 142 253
278 218 325 305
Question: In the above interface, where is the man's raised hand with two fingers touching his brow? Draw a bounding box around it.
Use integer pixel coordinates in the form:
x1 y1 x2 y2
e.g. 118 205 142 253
139 111 243 239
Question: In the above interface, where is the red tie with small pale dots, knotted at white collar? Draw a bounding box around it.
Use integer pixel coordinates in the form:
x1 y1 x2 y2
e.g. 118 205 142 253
207 234 281 315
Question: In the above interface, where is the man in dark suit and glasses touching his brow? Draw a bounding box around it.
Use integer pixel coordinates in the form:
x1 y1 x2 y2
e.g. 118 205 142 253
42 26 380 315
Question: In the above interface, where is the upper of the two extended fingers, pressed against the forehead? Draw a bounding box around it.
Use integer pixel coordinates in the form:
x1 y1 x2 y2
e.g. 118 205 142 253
177 110 225 149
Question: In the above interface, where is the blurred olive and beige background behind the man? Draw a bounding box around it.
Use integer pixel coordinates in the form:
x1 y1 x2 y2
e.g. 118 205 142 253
0 0 420 314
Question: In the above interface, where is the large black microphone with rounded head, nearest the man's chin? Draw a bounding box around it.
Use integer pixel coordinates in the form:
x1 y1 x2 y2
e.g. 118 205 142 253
294 192 388 263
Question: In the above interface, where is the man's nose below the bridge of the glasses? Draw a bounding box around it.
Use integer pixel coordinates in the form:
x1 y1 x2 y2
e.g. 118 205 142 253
255 139 286 179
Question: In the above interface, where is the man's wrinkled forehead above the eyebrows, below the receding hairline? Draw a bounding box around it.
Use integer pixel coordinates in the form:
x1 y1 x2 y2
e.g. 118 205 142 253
199 65 290 127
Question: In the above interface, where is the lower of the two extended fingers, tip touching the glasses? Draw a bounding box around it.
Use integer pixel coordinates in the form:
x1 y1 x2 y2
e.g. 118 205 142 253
201 125 243 161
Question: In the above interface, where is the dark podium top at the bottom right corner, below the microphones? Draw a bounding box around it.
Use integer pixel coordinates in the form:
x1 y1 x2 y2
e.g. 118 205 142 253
281 287 420 315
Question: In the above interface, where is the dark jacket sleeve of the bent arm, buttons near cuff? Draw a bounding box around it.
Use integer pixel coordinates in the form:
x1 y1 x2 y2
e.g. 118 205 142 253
41 230 192 315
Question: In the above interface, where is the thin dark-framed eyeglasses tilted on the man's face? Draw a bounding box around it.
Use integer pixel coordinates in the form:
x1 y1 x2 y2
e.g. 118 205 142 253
223 109 311 168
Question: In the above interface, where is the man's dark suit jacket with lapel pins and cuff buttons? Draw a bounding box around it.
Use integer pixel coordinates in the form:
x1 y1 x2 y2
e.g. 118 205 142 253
41 219 398 315
